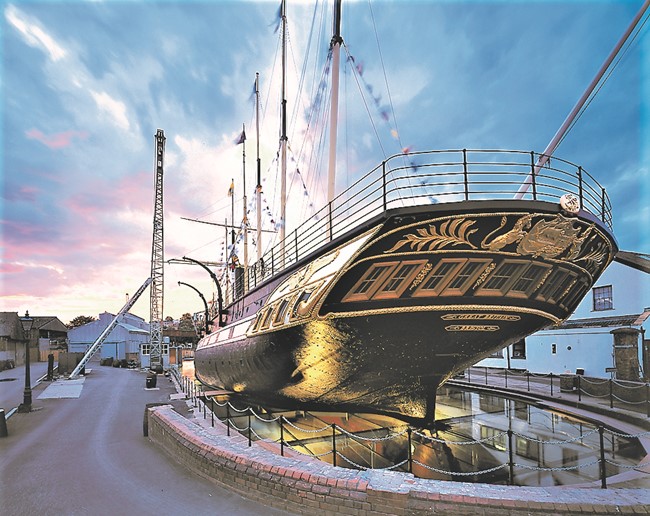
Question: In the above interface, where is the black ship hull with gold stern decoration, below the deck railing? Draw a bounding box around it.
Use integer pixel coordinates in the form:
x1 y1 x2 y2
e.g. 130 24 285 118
195 201 616 425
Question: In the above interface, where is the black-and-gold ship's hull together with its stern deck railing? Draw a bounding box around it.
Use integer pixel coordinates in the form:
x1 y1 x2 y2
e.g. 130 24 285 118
195 2 618 427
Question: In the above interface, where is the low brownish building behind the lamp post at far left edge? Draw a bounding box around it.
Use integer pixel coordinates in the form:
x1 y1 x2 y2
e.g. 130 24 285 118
0 312 68 371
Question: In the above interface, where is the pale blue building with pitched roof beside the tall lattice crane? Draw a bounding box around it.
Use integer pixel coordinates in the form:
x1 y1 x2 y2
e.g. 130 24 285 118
68 312 161 367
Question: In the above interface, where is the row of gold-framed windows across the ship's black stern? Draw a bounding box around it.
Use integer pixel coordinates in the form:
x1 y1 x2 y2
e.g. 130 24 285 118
343 258 600 308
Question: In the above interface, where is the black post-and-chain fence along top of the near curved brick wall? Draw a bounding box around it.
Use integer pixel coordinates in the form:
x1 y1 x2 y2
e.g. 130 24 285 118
171 370 650 489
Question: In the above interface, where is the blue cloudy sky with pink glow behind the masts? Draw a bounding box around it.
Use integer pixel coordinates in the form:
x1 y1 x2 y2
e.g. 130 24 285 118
0 0 650 323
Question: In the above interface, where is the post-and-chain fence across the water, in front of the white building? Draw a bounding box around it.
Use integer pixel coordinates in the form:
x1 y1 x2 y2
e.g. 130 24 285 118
456 367 650 418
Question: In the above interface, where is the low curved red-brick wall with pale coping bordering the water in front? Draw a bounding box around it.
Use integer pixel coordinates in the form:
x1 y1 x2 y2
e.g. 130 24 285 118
146 405 650 516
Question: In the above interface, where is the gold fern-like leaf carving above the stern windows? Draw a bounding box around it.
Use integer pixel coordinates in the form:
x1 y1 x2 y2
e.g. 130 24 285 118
384 219 478 253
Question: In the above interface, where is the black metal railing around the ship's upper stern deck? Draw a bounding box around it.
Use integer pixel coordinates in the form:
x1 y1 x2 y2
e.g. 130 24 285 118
227 149 612 301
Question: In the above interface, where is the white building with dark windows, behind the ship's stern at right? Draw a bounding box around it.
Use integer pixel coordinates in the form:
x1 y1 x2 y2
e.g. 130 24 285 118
476 262 650 380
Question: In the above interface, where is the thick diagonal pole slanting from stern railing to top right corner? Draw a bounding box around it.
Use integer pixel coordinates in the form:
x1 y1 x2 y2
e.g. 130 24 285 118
515 0 650 199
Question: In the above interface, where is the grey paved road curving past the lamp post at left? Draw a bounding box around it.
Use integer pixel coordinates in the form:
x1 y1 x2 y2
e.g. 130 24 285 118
0 365 286 516
